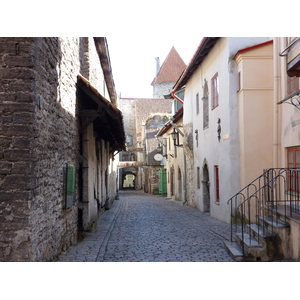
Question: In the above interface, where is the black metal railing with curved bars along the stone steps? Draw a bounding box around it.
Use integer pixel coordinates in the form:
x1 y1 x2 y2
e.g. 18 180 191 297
227 168 300 255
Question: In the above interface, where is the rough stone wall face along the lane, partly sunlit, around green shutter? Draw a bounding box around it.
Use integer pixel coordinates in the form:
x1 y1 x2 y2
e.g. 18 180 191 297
30 38 80 261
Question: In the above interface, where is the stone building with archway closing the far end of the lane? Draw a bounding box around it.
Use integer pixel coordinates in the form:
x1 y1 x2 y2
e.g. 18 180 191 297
119 98 172 193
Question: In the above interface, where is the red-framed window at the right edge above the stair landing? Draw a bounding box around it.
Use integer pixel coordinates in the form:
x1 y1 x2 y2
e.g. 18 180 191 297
287 148 300 193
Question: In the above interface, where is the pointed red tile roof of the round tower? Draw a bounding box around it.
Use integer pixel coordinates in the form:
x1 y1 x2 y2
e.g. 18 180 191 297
152 47 186 85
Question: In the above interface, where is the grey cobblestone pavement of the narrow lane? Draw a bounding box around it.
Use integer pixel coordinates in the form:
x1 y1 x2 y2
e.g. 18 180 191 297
58 191 233 262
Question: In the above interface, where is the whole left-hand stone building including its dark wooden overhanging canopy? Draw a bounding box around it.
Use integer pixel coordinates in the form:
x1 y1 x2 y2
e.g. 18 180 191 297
0 37 124 261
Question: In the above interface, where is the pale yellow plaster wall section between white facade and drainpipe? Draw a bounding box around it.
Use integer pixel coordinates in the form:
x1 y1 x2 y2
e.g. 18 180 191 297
236 44 273 188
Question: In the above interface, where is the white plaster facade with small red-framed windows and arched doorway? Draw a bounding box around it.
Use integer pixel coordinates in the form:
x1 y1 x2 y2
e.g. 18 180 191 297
183 37 269 222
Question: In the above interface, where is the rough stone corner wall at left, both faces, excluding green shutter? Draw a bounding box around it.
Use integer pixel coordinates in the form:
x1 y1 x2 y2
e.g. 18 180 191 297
0 38 80 261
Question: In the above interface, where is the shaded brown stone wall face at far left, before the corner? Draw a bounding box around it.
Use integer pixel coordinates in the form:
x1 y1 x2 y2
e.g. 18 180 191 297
0 38 35 261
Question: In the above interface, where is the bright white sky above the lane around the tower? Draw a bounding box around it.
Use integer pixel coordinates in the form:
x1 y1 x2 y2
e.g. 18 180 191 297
107 34 202 98
